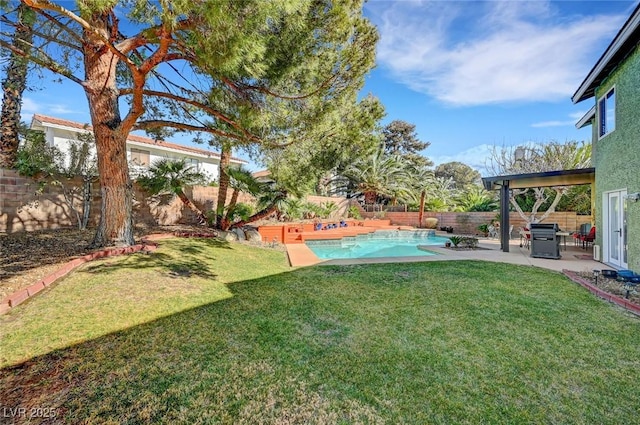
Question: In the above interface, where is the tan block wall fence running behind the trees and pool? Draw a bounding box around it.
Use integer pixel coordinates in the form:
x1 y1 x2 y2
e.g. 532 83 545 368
0 168 591 236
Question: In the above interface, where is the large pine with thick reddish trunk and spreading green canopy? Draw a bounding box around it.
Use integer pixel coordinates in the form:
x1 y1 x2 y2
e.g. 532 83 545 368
0 0 377 246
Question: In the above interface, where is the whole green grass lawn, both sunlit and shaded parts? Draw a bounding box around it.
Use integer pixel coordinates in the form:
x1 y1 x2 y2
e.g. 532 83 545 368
0 239 640 424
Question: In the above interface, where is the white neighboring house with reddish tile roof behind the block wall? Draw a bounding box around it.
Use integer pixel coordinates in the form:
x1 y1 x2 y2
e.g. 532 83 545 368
31 114 247 180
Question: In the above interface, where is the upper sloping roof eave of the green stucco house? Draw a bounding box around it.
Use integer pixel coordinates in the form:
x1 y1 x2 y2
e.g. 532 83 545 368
571 4 640 103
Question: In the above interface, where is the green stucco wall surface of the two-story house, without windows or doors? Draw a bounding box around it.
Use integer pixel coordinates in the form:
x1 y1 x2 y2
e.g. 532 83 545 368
592 47 640 272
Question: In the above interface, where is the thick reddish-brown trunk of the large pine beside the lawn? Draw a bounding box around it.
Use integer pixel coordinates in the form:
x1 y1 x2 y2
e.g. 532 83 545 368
83 15 135 247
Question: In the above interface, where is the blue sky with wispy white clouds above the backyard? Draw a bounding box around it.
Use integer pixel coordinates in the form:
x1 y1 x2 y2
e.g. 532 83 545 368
15 0 637 174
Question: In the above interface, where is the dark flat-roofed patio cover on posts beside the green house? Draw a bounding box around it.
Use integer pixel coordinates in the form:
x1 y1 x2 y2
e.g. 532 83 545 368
482 168 596 252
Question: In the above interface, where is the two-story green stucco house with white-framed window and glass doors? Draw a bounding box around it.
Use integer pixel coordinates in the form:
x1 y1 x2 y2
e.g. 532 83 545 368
572 1 640 272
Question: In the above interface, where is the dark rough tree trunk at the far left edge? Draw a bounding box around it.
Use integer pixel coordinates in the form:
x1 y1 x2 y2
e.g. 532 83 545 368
0 4 33 168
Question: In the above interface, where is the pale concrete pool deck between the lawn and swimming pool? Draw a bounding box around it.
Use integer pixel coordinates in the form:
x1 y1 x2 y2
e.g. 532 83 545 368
286 232 606 273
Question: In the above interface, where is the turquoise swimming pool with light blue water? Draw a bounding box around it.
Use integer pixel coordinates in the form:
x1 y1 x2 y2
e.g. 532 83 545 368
305 230 449 260
